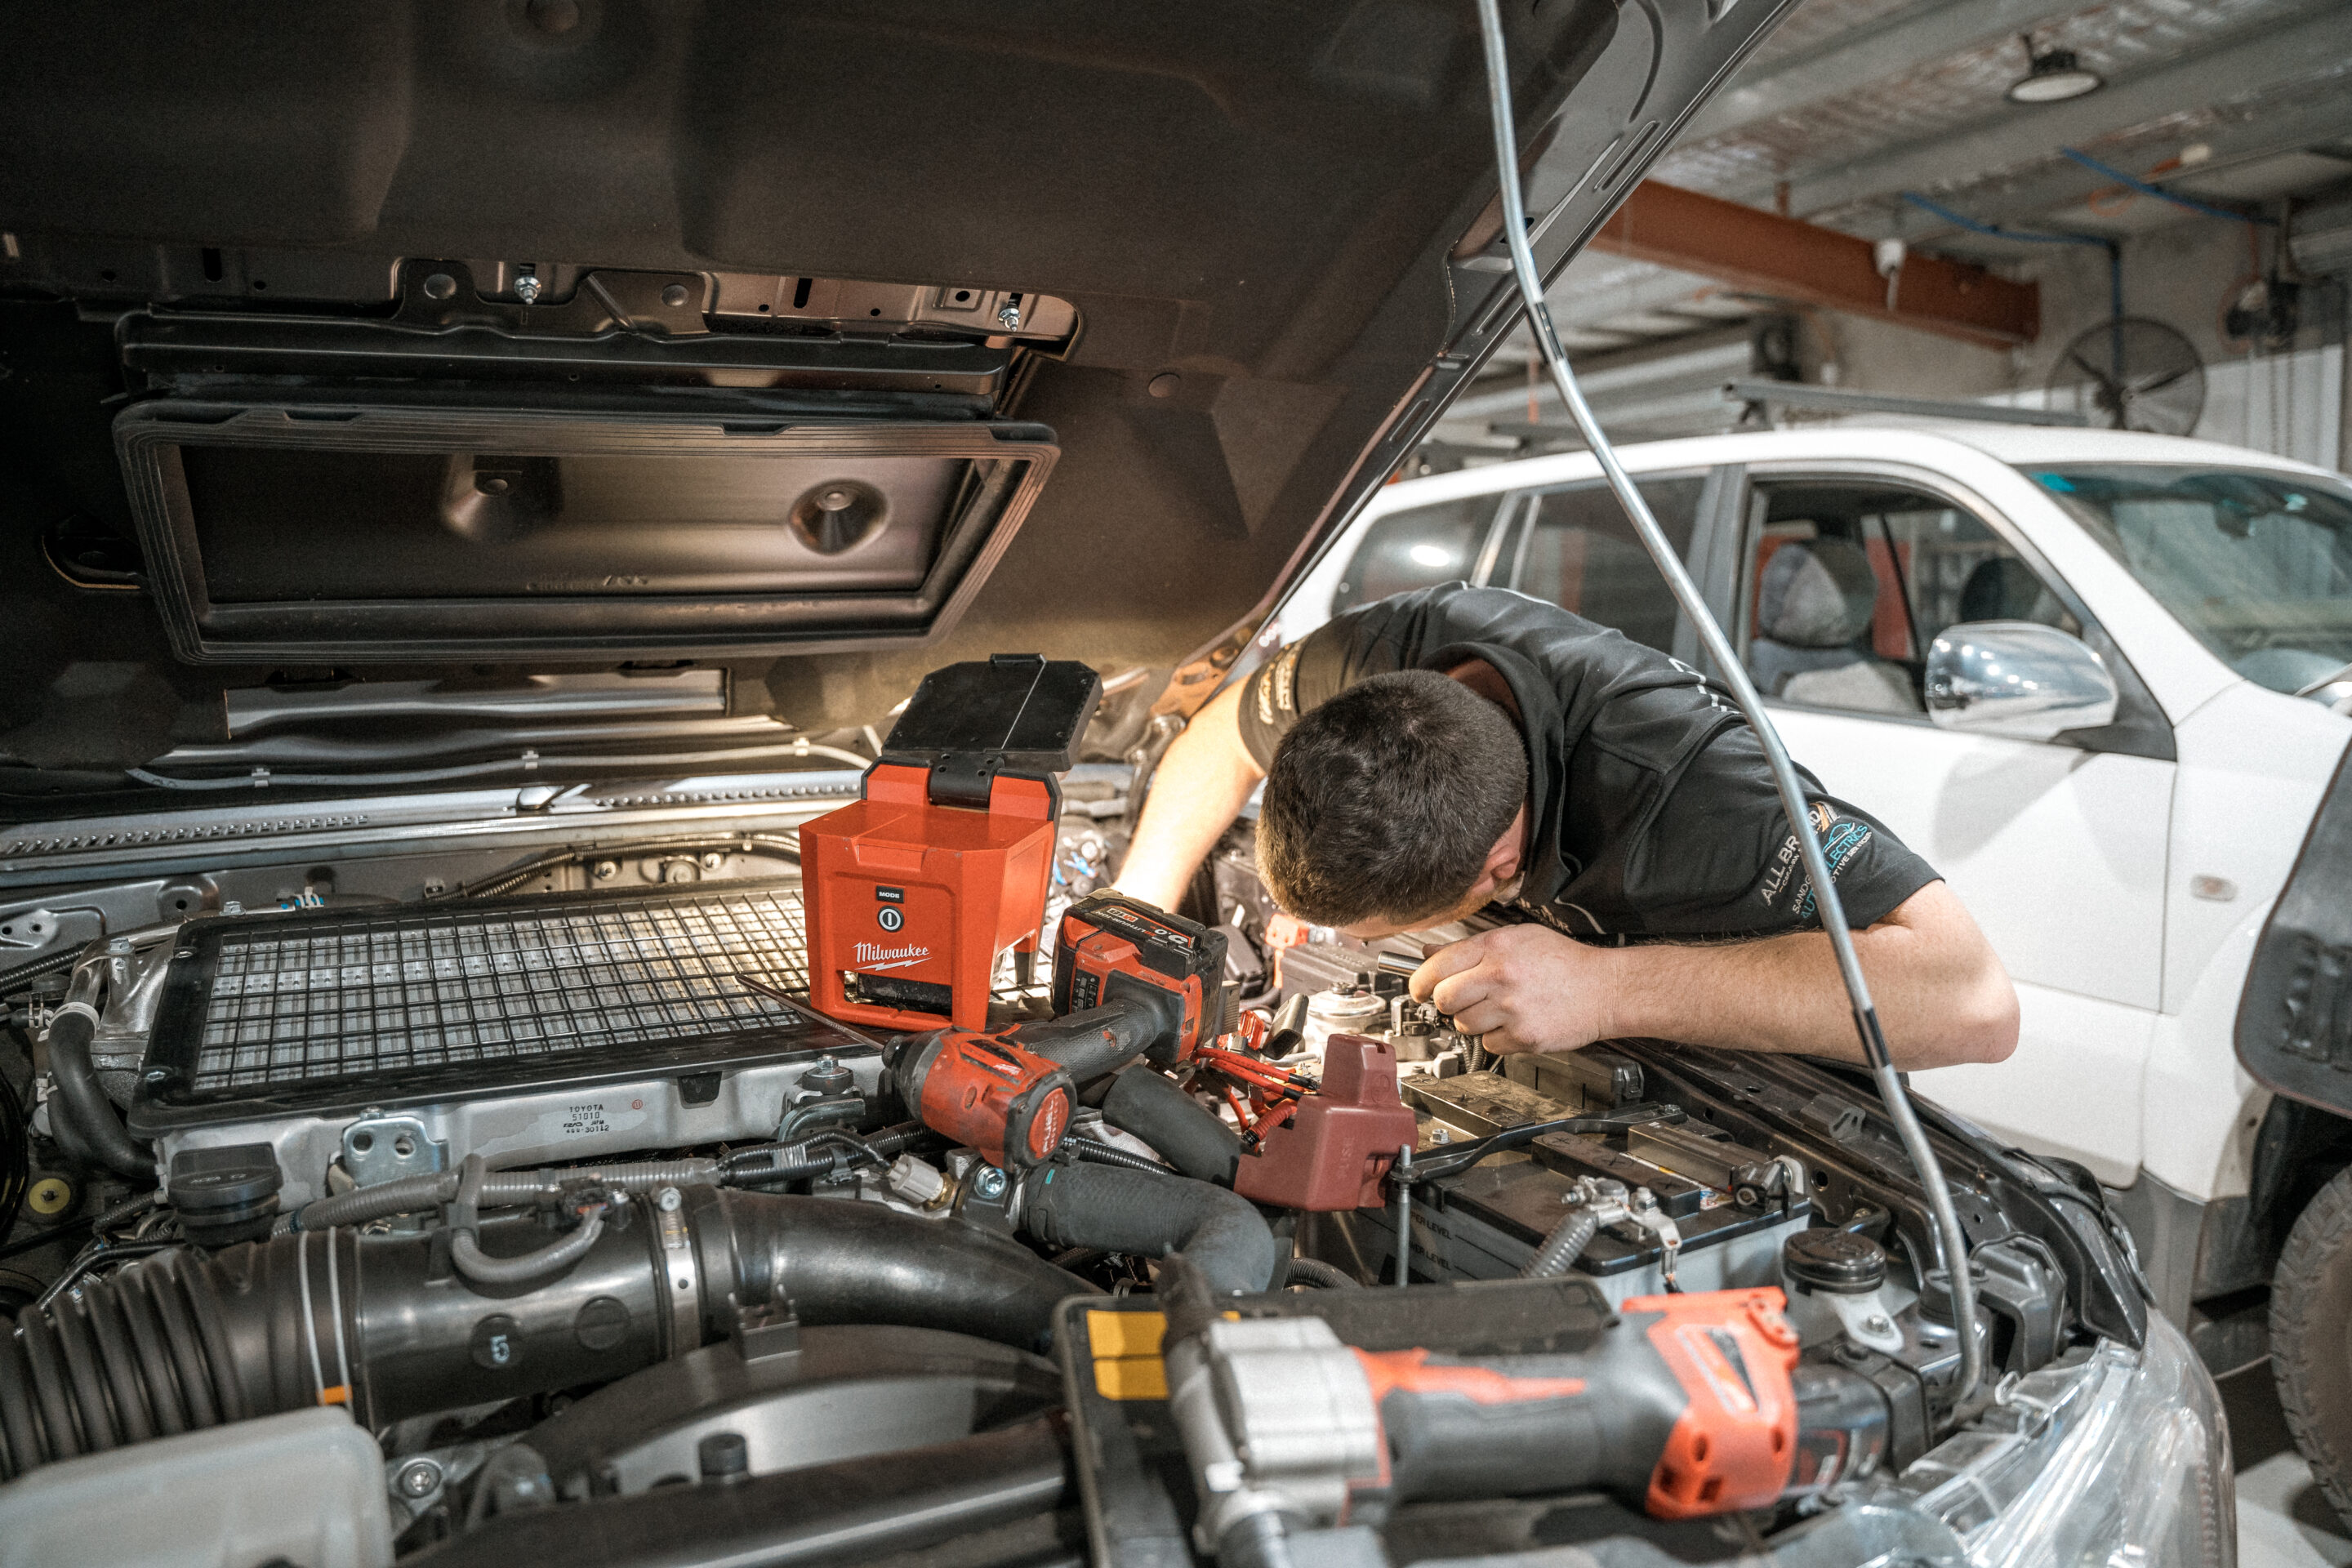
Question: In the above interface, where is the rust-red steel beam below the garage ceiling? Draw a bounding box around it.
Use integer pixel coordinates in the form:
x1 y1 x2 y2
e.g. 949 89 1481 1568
1592 181 2042 348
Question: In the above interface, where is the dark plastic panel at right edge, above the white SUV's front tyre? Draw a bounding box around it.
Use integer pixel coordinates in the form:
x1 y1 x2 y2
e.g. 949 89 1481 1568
2237 750 2352 1116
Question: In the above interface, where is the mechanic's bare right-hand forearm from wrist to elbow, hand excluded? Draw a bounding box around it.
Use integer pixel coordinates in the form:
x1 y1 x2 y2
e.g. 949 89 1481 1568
1609 884 2018 1070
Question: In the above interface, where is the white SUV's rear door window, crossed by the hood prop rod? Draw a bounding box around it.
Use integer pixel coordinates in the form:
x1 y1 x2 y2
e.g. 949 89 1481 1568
1496 474 1708 653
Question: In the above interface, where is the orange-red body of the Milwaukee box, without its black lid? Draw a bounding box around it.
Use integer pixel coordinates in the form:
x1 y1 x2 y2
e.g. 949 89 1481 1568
800 764 1054 1030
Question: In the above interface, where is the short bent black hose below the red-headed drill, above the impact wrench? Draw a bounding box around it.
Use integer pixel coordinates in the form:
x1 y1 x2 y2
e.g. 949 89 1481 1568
1020 1166 1280 1297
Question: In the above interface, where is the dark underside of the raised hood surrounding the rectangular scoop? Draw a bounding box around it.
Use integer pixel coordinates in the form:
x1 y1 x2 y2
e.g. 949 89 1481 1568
0 0 1780 816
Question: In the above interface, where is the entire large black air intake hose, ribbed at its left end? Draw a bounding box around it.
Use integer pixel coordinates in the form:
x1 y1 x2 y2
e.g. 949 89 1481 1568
0 1187 1087 1479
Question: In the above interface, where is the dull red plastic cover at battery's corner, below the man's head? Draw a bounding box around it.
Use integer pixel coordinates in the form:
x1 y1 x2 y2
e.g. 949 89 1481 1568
1232 1035 1419 1213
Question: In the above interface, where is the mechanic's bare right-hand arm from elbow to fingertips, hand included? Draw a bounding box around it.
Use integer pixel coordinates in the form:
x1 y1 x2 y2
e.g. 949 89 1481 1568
1414 881 2018 1070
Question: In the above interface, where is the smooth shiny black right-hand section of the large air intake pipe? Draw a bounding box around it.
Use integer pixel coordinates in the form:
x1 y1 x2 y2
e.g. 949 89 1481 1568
689 1189 1091 1349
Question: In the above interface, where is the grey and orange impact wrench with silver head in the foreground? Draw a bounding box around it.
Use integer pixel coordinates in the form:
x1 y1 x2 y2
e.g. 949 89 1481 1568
1160 1260 1889 1568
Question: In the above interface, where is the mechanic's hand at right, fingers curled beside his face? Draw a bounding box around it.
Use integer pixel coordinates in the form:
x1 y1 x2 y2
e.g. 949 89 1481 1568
1411 926 1620 1055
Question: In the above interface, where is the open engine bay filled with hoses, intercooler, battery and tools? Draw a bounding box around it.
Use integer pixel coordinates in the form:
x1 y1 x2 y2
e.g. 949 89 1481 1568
0 737 2201 1563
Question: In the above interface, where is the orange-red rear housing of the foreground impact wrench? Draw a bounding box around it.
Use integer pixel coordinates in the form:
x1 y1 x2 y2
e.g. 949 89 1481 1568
1618 1286 1797 1519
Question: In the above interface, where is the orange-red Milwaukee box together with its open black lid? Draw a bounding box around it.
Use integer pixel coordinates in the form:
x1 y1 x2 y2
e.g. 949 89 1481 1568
800 653 1103 1030
